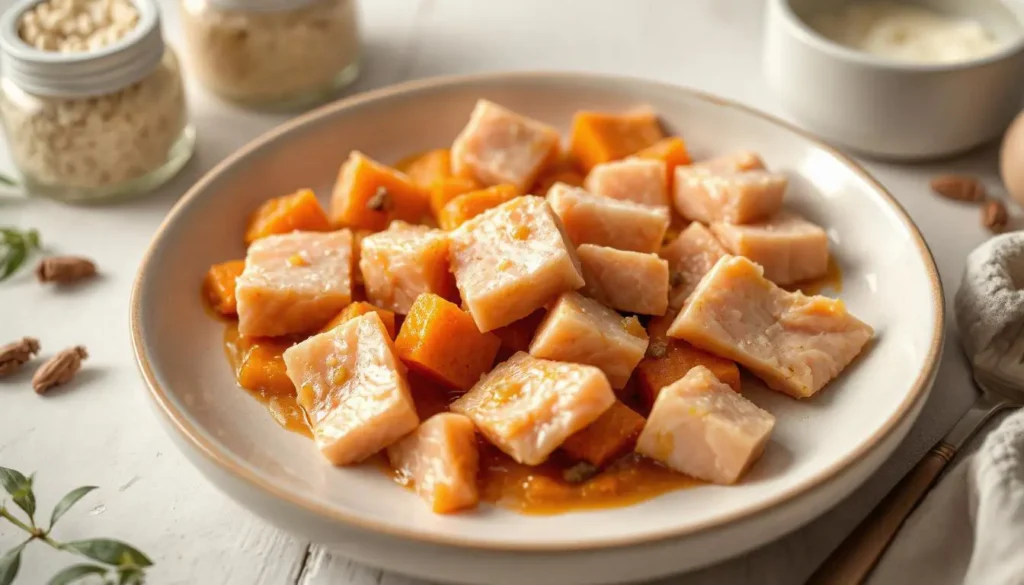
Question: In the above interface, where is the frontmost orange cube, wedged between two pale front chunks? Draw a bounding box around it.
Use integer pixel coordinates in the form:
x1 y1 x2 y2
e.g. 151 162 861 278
562 401 646 467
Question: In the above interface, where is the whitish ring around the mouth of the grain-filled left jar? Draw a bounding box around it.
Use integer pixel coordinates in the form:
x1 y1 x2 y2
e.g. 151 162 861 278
0 0 164 97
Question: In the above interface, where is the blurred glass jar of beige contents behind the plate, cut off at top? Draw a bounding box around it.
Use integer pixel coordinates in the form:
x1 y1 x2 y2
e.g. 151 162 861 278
181 0 359 110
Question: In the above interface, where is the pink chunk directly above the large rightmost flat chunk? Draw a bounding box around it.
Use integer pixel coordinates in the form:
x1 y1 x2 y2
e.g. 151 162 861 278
711 210 828 285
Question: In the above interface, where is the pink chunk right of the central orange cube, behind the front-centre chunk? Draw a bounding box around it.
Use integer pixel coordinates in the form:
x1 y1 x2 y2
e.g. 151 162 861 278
529 292 647 389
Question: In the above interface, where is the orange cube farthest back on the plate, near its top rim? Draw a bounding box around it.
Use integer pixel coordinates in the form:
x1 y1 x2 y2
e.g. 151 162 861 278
569 109 663 173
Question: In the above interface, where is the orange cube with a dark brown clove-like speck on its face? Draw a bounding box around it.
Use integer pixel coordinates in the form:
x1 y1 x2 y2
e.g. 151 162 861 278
331 152 429 232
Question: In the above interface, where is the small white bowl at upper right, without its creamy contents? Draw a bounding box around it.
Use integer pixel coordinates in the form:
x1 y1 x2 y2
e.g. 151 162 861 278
764 0 1024 160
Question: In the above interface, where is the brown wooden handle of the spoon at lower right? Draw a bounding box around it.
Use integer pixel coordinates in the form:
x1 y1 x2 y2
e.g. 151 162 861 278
807 442 956 585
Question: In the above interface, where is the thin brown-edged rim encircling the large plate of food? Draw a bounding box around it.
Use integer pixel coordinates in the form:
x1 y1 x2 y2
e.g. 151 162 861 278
129 71 945 552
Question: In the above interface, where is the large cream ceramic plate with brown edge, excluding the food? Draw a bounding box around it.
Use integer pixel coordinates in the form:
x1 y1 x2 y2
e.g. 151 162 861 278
131 74 943 585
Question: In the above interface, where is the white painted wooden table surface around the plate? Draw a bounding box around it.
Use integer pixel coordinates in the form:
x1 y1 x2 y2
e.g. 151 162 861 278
0 0 1002 585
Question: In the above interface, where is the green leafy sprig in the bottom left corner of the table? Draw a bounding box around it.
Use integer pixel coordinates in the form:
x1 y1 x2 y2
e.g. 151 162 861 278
0 467 153 585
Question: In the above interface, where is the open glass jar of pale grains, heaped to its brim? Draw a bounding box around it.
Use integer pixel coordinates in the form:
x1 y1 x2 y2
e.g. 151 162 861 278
0 0 195 201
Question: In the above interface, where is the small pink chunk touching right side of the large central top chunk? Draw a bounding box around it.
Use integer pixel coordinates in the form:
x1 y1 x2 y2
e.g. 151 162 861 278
577 244 669 315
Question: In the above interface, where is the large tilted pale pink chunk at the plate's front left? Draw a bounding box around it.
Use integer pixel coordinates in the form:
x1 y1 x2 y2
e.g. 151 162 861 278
284 312 420 465
